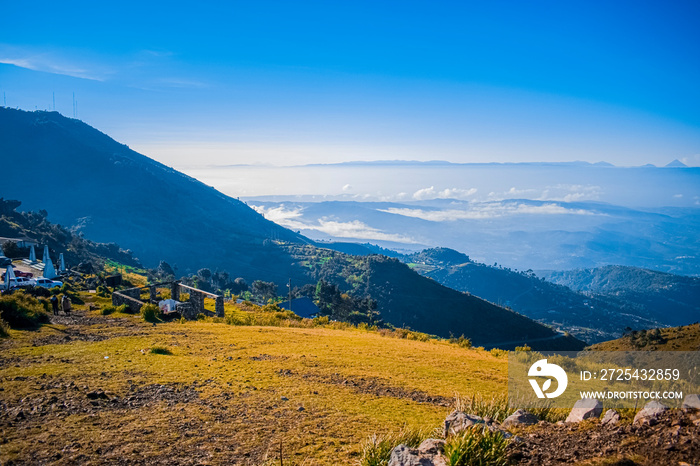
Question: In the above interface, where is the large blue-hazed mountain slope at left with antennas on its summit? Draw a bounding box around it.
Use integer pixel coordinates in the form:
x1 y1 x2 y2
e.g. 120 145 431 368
0 108 308 283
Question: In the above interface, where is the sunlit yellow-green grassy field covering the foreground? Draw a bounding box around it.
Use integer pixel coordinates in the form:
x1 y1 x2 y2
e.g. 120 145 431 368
0 295 507 465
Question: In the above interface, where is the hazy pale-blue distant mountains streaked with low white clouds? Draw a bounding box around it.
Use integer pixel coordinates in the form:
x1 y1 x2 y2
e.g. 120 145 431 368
247 198 700 275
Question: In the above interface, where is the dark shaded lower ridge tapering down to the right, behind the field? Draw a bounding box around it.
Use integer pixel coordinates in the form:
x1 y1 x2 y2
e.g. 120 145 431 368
289 246 585 350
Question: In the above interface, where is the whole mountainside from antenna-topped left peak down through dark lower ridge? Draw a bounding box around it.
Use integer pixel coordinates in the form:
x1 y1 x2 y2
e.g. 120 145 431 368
0 108 584 350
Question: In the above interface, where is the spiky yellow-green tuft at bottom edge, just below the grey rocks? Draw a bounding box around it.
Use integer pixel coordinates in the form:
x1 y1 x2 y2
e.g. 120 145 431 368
445 425 508 466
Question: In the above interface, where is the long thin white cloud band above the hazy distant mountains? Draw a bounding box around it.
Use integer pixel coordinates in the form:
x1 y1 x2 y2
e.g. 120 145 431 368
378 202 595 222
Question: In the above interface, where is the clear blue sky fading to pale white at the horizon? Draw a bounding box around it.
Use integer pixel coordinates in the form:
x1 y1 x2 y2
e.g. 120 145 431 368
0 0 700 167
